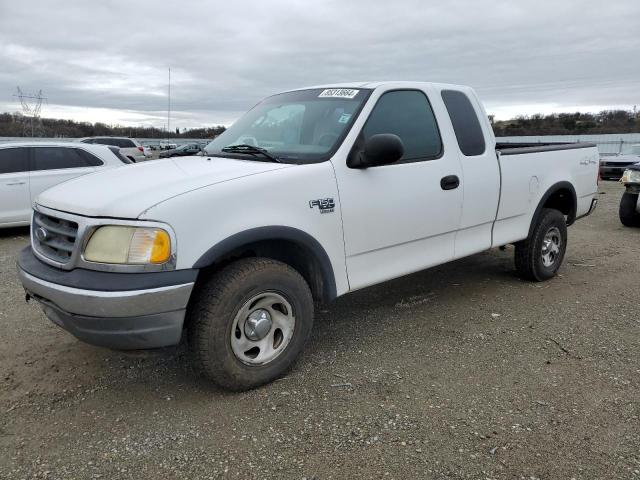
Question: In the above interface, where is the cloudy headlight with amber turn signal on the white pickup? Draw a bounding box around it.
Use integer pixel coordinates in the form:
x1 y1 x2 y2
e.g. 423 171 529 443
84 225 171 265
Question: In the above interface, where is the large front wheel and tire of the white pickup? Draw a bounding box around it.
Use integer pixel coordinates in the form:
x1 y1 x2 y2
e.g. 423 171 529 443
186 258 313 391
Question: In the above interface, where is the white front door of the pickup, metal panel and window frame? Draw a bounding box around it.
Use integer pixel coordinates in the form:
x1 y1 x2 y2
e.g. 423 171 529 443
332 82 462 290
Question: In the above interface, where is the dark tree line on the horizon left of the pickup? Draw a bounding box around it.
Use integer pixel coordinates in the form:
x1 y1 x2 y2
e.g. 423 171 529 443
0 113 225 139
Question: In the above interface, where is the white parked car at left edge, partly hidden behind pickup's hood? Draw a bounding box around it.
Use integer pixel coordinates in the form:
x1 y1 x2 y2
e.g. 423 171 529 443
0 142 130 228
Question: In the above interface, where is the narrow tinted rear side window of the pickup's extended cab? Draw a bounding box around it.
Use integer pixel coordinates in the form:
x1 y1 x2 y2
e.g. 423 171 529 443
442 90 485 157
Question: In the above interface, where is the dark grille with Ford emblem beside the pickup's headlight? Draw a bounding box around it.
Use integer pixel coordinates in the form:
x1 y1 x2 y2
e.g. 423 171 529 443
31 211 78 263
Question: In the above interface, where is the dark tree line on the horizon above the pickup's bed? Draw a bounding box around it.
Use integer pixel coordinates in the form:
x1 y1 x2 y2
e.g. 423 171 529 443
489 110 640 137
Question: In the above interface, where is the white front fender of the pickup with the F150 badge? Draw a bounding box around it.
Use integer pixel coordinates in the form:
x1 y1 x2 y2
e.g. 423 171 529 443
144 165 349 297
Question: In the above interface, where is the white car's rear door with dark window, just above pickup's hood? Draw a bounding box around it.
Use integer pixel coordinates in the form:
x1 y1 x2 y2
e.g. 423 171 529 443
30 146 103 202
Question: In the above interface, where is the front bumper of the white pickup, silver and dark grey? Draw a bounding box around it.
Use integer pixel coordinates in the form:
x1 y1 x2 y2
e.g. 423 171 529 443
18 247 197 350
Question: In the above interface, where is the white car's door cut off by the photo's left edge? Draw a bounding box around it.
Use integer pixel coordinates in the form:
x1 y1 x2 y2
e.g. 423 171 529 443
0 147 31 225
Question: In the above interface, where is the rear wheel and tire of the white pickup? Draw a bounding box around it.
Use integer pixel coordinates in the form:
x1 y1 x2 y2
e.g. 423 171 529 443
515 208 567 282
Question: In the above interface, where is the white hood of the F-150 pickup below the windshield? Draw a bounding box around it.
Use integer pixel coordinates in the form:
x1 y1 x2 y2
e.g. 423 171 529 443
36 156 294 218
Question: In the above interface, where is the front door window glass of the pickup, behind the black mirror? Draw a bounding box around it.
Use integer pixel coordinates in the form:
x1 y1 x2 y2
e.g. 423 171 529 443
362 90 442 163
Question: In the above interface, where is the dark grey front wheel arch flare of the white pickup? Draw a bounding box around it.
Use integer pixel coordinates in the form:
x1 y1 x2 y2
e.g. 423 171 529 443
193 225 337 302
